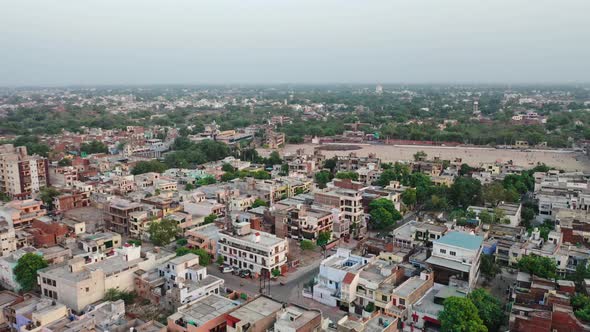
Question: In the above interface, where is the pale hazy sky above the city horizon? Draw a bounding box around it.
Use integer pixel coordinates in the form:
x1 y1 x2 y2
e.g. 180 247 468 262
0 0 590 86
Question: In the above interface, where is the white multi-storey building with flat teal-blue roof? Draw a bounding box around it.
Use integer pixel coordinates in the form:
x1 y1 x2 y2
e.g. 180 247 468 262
426 232 483 289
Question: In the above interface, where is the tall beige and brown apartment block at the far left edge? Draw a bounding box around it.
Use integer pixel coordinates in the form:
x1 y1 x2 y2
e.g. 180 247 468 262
0 144 49 199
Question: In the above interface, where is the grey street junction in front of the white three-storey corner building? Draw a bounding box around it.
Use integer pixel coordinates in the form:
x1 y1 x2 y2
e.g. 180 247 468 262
207 261 346 322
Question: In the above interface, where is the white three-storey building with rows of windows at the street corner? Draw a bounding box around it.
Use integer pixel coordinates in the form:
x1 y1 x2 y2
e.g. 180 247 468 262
218 222 289 275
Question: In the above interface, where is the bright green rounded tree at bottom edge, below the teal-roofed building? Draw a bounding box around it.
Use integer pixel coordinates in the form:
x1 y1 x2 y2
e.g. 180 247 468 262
438 296 487 332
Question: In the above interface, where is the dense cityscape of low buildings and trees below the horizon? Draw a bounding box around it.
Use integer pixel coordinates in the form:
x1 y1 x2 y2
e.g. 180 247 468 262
0 84 590 332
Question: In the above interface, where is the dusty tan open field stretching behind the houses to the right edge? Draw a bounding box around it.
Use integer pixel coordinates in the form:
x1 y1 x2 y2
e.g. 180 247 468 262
259 144 590 171
